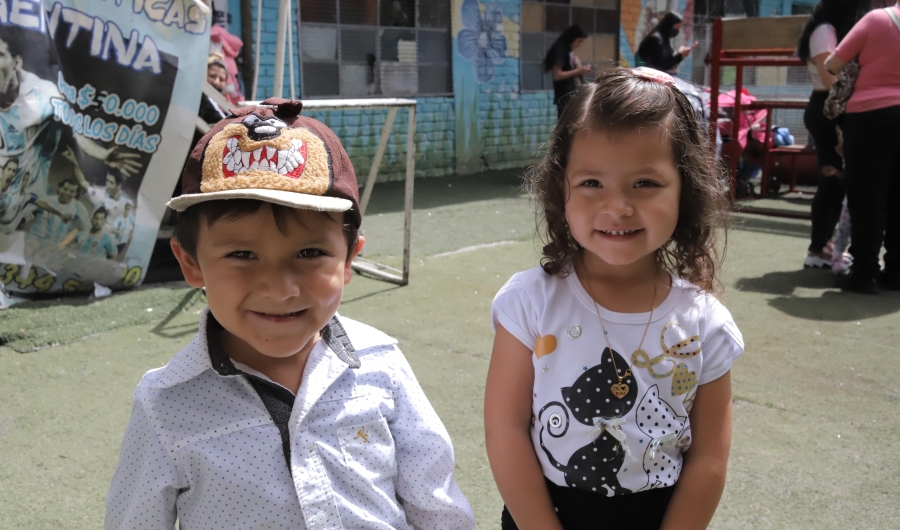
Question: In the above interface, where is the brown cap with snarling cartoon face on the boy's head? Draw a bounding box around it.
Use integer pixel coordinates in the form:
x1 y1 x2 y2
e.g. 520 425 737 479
167 98 362 228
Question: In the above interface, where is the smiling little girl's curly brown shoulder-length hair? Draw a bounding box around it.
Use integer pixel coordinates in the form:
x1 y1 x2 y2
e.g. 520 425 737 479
525 68 727 293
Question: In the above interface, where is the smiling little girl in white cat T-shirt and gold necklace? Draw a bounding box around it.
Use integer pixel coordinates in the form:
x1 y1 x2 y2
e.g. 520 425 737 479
485 68 744 530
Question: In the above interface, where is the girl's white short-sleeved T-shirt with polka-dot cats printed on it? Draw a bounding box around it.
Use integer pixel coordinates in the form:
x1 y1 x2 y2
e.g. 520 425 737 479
491 267 744 496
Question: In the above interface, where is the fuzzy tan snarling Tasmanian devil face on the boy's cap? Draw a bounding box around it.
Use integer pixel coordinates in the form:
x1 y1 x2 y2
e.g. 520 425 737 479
200 114 332 195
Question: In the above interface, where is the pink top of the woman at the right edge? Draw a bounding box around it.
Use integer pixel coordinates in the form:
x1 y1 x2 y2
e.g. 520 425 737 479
834 6 900 112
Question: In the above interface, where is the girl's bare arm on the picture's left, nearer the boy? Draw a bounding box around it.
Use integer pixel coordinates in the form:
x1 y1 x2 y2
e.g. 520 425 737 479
484 324 562 530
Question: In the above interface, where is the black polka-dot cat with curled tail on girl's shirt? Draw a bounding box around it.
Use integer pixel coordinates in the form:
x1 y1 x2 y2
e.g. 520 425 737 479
538 348 639 497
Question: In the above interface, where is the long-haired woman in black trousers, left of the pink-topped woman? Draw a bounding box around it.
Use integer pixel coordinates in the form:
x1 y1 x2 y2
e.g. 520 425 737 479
797 0 861 268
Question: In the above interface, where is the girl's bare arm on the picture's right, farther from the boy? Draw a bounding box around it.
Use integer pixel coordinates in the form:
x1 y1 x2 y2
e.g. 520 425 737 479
660 372 732 530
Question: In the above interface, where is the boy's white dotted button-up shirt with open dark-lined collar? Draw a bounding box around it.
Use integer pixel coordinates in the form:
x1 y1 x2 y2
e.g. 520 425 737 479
105 309 475 530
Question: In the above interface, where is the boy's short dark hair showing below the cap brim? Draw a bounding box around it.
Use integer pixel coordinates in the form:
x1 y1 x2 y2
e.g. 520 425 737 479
172 199 359 260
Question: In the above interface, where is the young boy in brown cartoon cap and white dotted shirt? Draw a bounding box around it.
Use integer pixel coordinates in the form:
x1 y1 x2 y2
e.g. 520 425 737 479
106 98 475 530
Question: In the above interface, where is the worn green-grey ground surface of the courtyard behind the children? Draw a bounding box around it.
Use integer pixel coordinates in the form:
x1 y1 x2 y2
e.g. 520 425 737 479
0 173 900 530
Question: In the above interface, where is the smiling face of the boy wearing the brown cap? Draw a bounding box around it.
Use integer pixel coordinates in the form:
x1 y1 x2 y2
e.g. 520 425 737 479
173 206 364 366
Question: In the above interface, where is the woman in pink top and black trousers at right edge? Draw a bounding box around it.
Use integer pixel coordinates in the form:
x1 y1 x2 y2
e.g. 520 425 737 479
825 5 900 294
